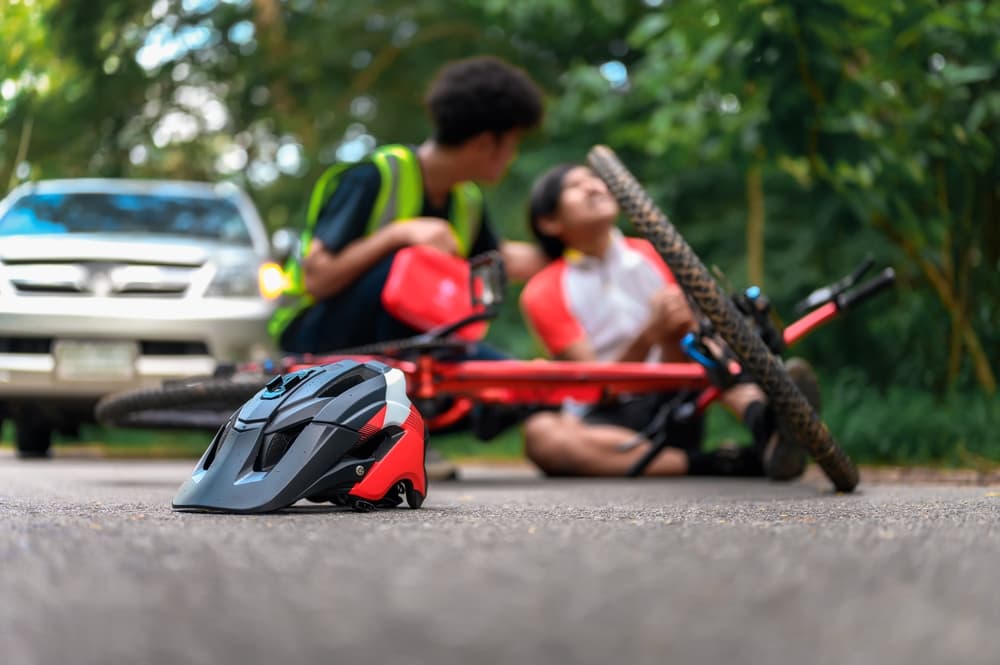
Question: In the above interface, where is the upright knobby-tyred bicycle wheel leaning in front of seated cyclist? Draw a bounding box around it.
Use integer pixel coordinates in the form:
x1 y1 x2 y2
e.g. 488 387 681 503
587 146 858 492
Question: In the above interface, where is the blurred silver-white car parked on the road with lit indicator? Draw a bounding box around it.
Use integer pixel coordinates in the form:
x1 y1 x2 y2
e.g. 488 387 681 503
0 179 283 456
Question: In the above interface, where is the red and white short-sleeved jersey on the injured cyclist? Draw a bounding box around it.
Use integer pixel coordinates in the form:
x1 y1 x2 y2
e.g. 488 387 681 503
521 229 676 360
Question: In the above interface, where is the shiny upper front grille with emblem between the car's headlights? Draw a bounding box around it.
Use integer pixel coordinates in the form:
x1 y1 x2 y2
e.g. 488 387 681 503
5 262 198 298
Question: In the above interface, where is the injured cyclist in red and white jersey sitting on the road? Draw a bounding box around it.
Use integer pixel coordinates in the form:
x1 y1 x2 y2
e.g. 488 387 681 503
521 164 819 480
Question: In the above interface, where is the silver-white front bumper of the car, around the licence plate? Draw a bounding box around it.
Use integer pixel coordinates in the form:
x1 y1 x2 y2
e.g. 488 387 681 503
0 297 273 401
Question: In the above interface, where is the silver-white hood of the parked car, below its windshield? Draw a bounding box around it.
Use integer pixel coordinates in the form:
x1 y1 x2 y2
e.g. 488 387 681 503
0 233 254 266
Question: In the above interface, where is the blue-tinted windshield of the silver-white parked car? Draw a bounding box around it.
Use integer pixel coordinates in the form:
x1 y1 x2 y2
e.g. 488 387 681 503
0 193 251 245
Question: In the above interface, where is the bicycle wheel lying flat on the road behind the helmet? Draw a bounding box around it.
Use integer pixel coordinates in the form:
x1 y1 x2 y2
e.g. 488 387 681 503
94 376 271 430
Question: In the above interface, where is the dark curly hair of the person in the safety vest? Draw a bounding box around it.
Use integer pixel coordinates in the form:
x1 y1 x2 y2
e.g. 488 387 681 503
424 56 542 146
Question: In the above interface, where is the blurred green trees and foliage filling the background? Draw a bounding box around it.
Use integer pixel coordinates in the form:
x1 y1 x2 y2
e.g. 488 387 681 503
0 0 1000 465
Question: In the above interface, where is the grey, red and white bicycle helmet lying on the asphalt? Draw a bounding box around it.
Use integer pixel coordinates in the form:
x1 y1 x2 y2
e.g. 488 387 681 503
173 360 427 513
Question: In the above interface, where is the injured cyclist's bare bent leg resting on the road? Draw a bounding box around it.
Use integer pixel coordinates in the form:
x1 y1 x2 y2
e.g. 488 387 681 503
524 412 688 476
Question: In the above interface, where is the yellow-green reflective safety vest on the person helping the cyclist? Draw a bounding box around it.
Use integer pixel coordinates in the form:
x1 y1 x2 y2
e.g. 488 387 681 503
268 145 483 343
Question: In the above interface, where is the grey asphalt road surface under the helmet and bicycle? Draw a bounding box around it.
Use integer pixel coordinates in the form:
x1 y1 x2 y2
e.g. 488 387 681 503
0 453 1000 665
